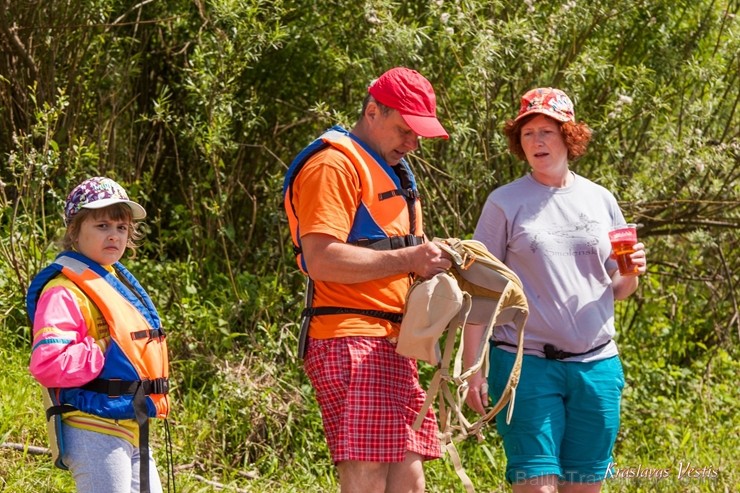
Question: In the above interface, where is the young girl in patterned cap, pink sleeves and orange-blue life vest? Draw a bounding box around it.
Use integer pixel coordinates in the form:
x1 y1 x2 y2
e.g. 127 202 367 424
26 177 169 493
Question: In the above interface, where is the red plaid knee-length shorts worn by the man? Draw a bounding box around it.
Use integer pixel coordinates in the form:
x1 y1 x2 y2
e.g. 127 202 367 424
304 337 442 463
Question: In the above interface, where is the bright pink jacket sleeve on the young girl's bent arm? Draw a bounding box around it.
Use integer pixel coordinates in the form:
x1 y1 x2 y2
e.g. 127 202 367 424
29 286 105 388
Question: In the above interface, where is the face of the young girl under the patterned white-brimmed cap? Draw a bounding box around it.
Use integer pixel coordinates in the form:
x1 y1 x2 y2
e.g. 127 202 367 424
75 214 131 265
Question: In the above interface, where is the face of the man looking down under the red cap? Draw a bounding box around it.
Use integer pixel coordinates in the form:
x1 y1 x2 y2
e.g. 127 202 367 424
365 102 419 166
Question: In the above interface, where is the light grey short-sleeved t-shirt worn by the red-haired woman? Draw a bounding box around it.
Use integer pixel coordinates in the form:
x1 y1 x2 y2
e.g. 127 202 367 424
473 173 625 362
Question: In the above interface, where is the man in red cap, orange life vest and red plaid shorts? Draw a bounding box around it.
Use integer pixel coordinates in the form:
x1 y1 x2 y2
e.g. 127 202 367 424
283 67 450 493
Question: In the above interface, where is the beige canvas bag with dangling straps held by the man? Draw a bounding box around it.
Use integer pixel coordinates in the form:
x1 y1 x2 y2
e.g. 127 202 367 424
396 238 529 492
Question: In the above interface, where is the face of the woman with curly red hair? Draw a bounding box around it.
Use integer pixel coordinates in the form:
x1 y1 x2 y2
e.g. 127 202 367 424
520 115 568 176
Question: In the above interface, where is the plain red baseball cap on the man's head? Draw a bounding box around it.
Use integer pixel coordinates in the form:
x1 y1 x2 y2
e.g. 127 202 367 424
367 67 449 139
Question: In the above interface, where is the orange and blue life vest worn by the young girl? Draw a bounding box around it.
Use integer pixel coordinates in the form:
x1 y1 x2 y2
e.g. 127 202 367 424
26 252 170 477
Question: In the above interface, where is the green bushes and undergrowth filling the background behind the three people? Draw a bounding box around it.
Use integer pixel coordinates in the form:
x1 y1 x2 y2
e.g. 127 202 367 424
0 0 740 492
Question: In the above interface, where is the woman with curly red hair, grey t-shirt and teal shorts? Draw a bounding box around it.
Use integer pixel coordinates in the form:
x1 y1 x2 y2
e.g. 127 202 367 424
465 87 646 493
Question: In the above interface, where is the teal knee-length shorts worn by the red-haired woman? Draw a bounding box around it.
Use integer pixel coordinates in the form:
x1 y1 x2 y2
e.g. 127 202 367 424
488 346 624 483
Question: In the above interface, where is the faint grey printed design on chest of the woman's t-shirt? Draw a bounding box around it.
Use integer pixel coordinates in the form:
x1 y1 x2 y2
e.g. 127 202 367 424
529 214 601 257
